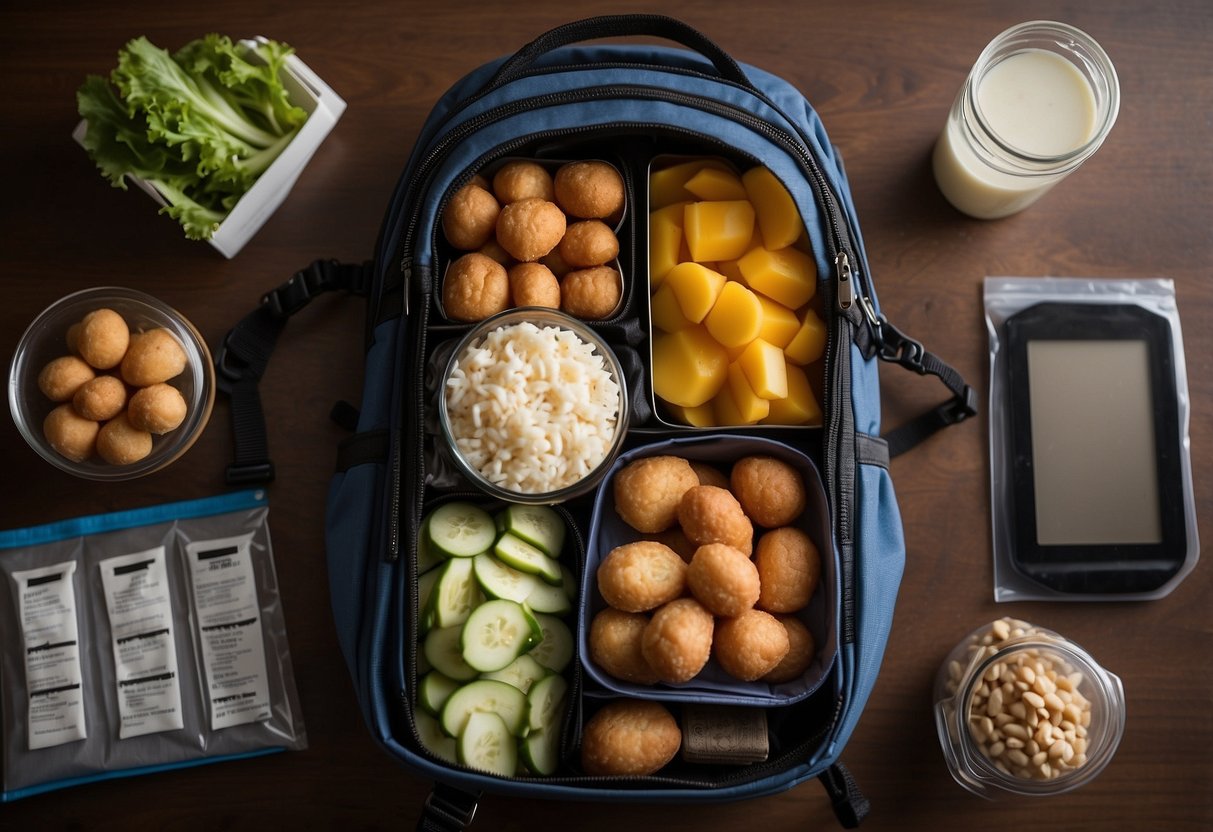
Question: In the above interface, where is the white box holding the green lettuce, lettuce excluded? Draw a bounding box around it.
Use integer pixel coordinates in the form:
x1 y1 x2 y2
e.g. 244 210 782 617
72 36 346 258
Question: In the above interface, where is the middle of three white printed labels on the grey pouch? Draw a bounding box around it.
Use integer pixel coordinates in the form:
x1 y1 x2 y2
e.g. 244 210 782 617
98 546 184 740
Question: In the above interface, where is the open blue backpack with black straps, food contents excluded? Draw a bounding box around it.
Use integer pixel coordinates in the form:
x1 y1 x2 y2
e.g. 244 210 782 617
216 15 976 830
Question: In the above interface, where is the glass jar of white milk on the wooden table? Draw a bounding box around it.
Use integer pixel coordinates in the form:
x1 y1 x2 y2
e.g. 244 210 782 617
933 21 1121 220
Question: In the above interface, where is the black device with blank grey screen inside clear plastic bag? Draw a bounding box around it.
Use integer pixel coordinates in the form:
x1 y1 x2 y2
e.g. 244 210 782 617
1006 302 1188 594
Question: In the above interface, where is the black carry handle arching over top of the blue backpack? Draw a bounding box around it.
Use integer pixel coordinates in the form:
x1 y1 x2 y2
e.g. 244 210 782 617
484 15 753 92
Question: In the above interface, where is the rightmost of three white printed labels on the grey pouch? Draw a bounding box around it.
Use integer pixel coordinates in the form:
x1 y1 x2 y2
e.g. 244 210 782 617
186 535 269 730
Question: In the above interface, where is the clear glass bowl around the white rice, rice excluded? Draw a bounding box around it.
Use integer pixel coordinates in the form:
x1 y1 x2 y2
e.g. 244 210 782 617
438 307 630 505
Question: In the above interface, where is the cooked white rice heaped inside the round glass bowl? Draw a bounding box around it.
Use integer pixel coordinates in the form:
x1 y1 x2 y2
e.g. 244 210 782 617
445 323 620 494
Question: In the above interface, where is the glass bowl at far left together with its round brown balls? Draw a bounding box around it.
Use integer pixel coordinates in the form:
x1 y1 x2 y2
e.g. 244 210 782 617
8 286 215 481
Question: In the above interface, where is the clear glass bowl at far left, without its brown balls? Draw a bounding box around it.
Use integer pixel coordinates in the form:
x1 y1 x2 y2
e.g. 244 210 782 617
8 286 215 481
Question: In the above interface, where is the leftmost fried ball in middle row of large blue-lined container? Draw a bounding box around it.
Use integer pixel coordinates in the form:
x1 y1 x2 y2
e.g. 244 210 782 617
598 540 687 612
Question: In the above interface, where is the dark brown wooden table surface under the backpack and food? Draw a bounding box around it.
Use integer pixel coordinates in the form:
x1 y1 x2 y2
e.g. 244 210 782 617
0 0 1213 832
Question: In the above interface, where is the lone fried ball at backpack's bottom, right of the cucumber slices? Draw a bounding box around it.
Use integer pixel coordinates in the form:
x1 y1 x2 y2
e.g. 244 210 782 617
581 699 682 776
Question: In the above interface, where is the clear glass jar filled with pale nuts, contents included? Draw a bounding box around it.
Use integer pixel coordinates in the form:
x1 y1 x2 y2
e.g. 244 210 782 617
934 619 1124 798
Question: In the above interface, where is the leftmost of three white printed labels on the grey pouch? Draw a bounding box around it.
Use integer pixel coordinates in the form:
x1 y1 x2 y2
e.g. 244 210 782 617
12 562 87 751
